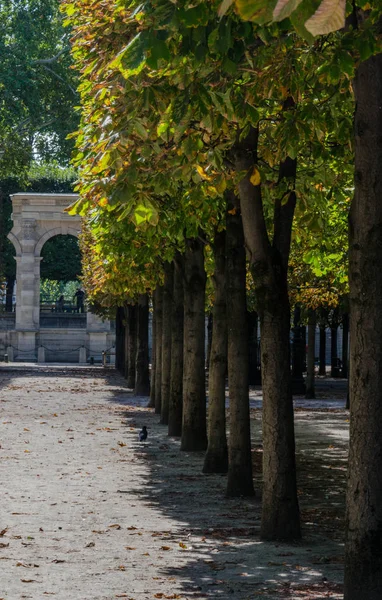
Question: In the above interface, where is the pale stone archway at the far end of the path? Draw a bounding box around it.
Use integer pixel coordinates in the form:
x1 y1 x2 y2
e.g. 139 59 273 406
8 193 110 360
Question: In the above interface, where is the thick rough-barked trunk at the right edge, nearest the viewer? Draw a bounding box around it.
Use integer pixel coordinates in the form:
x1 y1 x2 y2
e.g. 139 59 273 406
344 54 382 600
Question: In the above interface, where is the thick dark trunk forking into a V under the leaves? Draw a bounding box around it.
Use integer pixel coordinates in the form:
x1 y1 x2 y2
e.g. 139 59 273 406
235 124 301 540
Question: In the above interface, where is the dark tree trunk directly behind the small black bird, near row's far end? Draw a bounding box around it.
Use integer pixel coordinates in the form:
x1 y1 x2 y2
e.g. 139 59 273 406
134 294 150 396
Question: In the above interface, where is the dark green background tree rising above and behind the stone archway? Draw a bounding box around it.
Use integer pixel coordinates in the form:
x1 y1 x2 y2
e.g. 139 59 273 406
0 0 78 178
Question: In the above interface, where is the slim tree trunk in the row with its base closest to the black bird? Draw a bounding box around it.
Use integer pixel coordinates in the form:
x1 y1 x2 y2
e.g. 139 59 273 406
160 263 174 425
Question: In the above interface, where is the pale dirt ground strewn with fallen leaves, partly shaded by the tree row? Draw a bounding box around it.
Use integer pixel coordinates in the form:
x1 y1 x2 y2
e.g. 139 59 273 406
0 365 348 600
